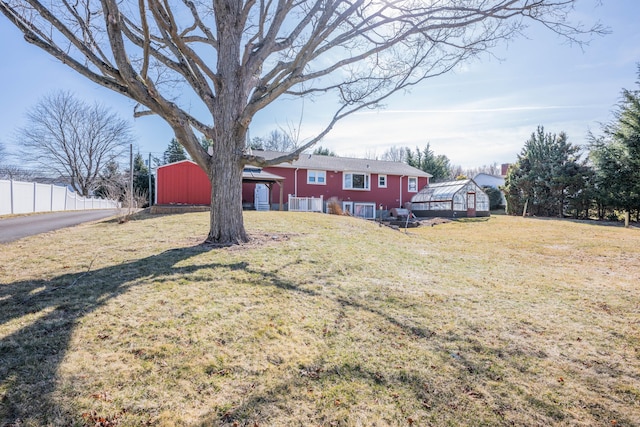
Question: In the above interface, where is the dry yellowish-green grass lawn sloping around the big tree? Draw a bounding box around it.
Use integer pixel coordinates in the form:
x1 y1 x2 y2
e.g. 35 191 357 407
0 212 640 427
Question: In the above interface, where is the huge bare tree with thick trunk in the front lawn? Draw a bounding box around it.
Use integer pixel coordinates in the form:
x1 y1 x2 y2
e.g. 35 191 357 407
0 0 601 243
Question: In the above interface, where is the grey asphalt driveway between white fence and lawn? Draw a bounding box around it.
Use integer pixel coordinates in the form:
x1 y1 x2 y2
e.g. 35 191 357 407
0 209 118 243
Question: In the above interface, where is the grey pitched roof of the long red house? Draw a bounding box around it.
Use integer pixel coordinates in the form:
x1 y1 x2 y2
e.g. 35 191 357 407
253 150 433 178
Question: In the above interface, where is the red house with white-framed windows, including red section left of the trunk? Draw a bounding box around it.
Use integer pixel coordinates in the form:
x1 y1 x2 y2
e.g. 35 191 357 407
156 151 431 218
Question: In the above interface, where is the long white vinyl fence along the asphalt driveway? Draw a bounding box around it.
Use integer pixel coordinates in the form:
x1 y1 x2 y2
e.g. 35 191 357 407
0 180 119 215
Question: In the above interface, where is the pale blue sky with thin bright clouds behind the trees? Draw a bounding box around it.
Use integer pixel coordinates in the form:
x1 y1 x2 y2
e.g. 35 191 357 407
0 0 640 168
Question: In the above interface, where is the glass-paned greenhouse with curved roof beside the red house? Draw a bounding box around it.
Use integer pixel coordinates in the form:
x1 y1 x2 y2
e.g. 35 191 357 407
411 179 490 218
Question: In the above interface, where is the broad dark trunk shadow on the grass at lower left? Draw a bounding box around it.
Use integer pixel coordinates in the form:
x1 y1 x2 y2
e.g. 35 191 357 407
0 245 246 426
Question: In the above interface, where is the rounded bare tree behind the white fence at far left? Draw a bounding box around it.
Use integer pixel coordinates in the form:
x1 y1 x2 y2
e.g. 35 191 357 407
17 92 132 196
